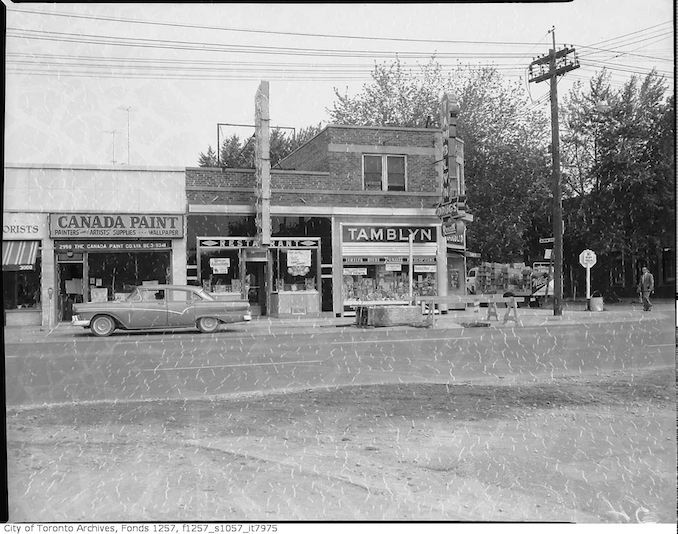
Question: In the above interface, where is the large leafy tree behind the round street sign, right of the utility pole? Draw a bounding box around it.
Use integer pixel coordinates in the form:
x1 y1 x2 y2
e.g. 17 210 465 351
563 71 675 292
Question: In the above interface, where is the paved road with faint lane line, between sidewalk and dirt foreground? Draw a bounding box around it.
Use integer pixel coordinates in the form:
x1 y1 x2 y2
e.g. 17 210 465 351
5 318 675 407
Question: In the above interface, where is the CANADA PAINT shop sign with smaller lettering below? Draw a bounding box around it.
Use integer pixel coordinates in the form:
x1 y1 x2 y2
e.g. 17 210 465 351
49 213 184 239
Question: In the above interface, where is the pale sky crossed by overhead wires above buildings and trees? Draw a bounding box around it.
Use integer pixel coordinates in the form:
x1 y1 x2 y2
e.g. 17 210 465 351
2 0 675 168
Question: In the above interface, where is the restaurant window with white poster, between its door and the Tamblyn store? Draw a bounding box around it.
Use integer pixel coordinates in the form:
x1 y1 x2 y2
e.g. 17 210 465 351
273 249 318 291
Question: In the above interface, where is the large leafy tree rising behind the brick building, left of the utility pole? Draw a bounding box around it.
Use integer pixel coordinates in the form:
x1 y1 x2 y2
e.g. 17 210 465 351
328 57 549 261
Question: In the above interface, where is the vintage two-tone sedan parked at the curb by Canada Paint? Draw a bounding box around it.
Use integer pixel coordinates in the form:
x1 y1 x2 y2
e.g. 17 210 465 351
71 285 252 336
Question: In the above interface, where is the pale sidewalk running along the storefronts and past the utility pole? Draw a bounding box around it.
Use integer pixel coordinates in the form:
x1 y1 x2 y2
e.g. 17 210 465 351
3 300 675 343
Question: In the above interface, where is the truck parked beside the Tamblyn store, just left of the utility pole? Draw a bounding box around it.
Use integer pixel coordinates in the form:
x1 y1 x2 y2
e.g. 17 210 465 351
466 262 553 306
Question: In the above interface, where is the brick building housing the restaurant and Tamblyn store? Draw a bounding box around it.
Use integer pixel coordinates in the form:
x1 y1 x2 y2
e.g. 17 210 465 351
186 125 465 315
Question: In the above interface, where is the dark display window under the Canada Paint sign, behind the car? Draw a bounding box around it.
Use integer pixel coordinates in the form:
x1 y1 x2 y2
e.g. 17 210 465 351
88 251 171 301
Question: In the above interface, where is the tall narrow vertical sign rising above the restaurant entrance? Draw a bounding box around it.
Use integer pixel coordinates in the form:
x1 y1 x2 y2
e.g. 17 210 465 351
254 81 271 245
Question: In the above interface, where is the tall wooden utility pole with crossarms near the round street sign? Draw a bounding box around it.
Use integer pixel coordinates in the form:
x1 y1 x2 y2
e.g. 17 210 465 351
529 27 579 315
